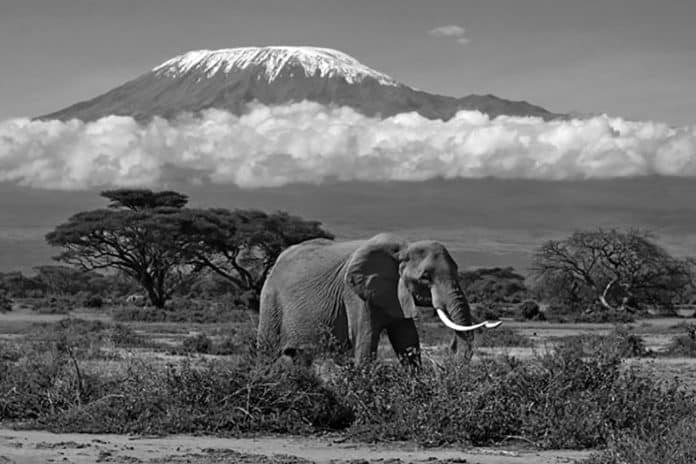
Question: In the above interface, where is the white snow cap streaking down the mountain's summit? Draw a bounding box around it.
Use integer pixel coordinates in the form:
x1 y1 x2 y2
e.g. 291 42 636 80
153 46 399 86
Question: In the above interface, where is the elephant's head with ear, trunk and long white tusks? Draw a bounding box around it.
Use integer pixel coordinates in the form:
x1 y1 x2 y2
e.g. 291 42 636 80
346 234 500 358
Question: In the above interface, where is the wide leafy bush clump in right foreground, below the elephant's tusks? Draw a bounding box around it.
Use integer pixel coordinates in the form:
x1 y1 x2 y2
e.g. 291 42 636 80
334 342 696 448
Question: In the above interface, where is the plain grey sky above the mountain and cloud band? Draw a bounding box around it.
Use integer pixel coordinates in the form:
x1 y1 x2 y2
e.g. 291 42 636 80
0 0 696 126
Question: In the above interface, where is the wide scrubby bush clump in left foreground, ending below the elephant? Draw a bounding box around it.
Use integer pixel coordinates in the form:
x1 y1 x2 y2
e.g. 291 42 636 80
0 352 352 434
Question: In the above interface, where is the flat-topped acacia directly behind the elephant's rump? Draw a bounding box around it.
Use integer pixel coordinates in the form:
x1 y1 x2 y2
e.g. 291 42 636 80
185 209 334 295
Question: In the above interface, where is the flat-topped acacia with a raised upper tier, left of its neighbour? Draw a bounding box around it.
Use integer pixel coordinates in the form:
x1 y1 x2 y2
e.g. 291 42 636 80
46 189 198 308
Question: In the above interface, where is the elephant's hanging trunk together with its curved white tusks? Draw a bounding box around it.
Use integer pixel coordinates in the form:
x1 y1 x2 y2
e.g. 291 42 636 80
431 282 500 354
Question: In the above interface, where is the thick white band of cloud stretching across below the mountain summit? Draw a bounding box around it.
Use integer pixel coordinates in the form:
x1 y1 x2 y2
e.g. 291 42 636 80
0 102 696 190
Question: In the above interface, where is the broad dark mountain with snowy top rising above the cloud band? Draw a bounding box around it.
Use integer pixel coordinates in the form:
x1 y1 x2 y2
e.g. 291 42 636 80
39 47 563 121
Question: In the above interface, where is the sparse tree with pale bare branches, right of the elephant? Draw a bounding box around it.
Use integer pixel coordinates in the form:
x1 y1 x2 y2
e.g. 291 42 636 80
532 229 692 311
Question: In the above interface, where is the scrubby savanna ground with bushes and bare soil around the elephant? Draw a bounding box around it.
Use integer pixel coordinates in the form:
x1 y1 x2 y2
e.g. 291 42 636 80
0 298 696 464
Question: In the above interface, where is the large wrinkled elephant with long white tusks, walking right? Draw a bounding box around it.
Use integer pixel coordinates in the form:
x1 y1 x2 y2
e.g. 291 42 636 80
257 233 501 365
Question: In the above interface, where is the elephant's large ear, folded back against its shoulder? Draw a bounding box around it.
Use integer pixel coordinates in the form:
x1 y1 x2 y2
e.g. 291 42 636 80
345 243 403 317
